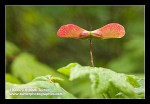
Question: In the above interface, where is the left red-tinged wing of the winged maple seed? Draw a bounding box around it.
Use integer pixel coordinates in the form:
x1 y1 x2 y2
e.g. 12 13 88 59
57 24 90 39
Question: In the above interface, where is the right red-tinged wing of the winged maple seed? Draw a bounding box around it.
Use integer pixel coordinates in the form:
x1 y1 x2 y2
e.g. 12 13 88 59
91 23 125 39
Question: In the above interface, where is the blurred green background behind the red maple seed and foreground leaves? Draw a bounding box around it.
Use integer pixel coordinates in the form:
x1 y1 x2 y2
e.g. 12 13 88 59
5 6 145 83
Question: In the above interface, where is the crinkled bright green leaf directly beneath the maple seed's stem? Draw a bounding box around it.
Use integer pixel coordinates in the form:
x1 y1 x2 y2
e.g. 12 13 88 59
58 63 144 98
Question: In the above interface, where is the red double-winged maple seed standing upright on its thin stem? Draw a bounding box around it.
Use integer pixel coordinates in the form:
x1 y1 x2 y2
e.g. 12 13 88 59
57 23 125 67
